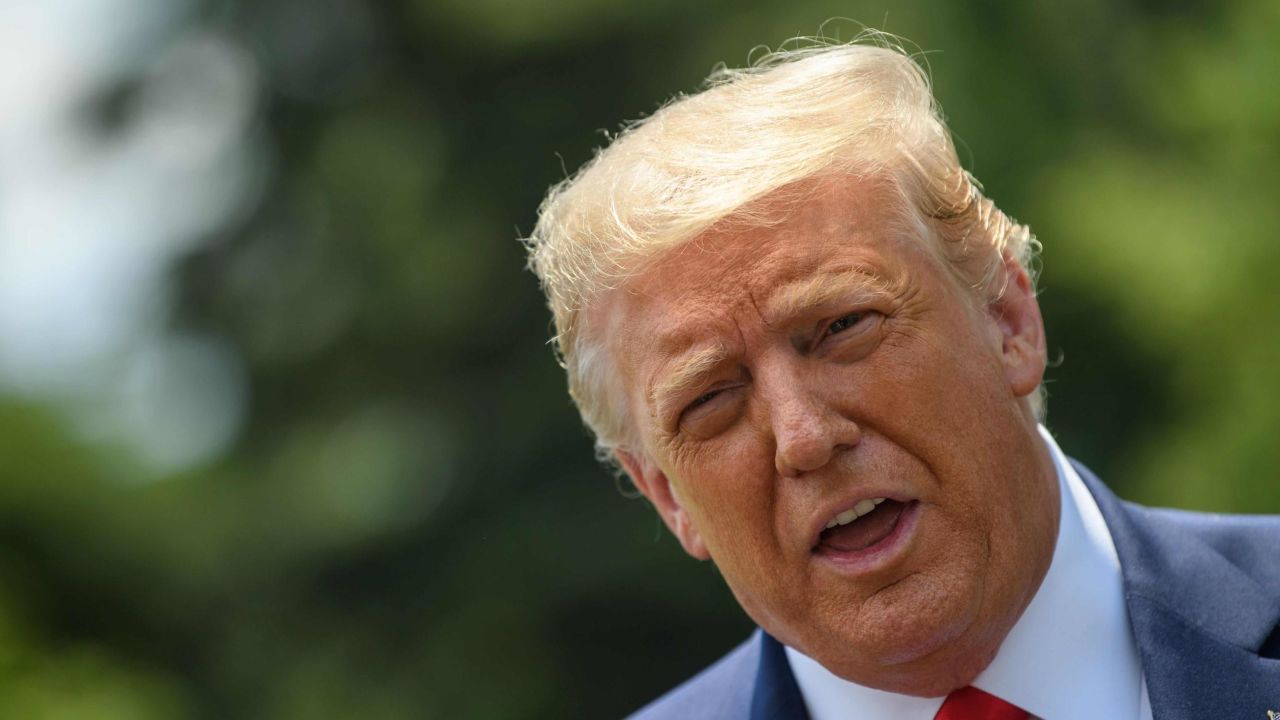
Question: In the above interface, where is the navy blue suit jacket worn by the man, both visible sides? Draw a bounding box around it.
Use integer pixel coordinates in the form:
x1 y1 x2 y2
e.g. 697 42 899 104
632 464 1280 720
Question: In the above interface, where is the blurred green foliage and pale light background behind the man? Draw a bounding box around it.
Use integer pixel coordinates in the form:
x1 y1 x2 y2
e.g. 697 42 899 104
0 0 1280 720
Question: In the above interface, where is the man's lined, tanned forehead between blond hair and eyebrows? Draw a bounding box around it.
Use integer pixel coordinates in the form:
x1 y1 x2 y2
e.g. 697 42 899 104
595 178 929 340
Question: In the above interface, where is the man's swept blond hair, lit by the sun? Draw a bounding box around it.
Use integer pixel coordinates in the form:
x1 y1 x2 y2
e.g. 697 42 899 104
525 32 1043 457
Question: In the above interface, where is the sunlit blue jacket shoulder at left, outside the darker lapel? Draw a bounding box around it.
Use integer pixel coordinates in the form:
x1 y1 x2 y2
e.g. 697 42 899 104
630 630 760 720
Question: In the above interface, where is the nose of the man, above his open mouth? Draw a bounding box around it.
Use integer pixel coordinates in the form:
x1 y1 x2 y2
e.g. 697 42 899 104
769 368 861 478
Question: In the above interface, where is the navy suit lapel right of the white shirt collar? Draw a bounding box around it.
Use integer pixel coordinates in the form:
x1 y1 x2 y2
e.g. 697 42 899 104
1075 464 1280 720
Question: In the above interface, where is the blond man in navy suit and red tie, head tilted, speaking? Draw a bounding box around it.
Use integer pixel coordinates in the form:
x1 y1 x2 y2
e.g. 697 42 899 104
530 44 1280 720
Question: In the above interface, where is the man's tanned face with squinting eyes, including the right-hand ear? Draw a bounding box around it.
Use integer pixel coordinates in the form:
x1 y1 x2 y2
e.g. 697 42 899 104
593 172 1059 696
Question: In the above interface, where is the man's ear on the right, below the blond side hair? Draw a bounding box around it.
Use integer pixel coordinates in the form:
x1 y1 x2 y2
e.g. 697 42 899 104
988 254 1047 397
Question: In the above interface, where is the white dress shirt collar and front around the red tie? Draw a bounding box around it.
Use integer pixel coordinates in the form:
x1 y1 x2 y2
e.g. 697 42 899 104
786 425 1151 720
